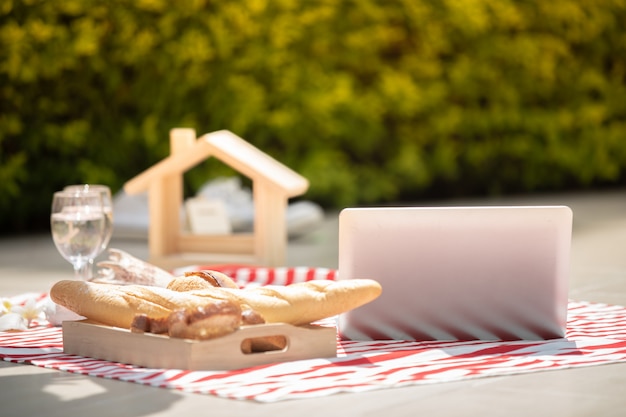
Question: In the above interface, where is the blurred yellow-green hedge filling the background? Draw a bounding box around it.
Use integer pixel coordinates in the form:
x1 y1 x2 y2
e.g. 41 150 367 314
0 0 626 232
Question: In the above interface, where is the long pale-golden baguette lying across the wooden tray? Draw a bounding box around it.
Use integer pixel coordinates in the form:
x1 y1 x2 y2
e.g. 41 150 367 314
50 279 382 328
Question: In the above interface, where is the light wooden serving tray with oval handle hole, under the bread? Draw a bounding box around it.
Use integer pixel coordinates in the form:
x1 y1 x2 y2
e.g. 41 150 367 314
62 320 337 370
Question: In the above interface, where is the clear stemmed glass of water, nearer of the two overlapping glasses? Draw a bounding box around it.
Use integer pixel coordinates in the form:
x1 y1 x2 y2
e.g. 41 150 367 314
50 191 105 281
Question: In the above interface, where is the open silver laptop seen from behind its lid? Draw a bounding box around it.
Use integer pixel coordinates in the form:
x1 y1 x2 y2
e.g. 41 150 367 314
338 206 573 341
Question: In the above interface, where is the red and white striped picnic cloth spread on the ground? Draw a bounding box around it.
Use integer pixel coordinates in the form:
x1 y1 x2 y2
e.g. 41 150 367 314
0 266 626 402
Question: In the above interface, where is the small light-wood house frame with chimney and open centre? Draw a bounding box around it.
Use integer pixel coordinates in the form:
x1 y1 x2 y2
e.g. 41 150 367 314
124 128 309 269
